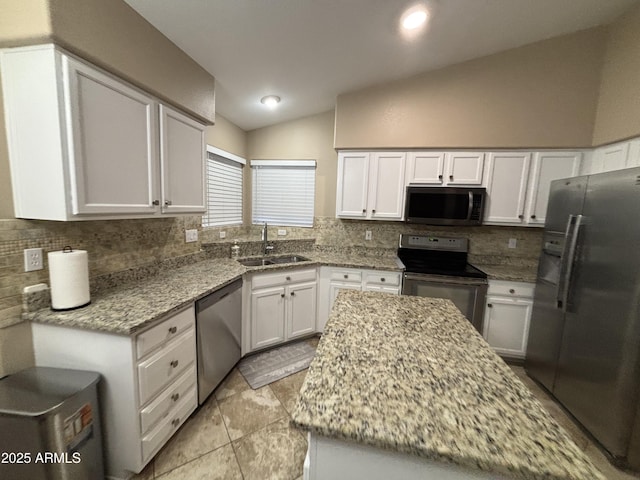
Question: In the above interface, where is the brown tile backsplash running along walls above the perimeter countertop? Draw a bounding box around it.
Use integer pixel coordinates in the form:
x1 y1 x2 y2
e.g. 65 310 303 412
0 215 542 328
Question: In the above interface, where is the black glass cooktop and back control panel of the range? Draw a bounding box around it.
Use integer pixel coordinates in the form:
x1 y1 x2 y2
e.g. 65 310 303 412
398 235 487 278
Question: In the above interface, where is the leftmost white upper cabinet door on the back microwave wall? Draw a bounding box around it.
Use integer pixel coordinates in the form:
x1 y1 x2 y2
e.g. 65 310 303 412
336 152 369 218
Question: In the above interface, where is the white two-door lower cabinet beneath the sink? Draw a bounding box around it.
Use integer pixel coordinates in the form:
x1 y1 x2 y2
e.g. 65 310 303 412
248 268 317 354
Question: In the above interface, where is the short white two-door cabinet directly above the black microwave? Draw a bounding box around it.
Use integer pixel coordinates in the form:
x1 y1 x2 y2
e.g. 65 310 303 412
406 151 484 186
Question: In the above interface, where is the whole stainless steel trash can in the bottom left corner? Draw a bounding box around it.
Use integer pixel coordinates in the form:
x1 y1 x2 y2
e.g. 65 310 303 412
0 367 104 480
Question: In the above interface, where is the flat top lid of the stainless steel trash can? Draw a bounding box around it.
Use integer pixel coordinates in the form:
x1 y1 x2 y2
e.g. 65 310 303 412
0 367 100 417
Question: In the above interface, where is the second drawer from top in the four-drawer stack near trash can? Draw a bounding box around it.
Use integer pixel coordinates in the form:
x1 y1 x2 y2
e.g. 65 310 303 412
138 328 196 405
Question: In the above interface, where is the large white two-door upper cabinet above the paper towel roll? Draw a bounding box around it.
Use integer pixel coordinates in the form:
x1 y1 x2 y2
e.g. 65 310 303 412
0 45 205 220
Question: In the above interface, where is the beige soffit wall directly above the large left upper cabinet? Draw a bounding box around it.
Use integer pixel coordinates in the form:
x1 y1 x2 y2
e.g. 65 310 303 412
0 0 215 124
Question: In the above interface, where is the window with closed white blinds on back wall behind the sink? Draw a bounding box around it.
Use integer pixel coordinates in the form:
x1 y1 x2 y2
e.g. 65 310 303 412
251 160 316 227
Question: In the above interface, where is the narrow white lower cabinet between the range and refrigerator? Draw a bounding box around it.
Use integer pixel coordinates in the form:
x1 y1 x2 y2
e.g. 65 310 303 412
483 280 535 358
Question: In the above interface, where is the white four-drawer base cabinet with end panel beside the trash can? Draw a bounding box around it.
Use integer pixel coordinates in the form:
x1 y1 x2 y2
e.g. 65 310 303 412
32 306 198 479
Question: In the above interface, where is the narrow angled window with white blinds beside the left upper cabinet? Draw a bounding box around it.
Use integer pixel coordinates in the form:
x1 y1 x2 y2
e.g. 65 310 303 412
202 145 246 227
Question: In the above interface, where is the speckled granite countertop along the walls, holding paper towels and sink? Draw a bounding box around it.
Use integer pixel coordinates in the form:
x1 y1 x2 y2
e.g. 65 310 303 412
23 252 402 335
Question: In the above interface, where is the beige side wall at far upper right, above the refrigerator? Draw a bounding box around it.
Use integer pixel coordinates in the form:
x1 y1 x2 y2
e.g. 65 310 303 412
593 6 640 145
